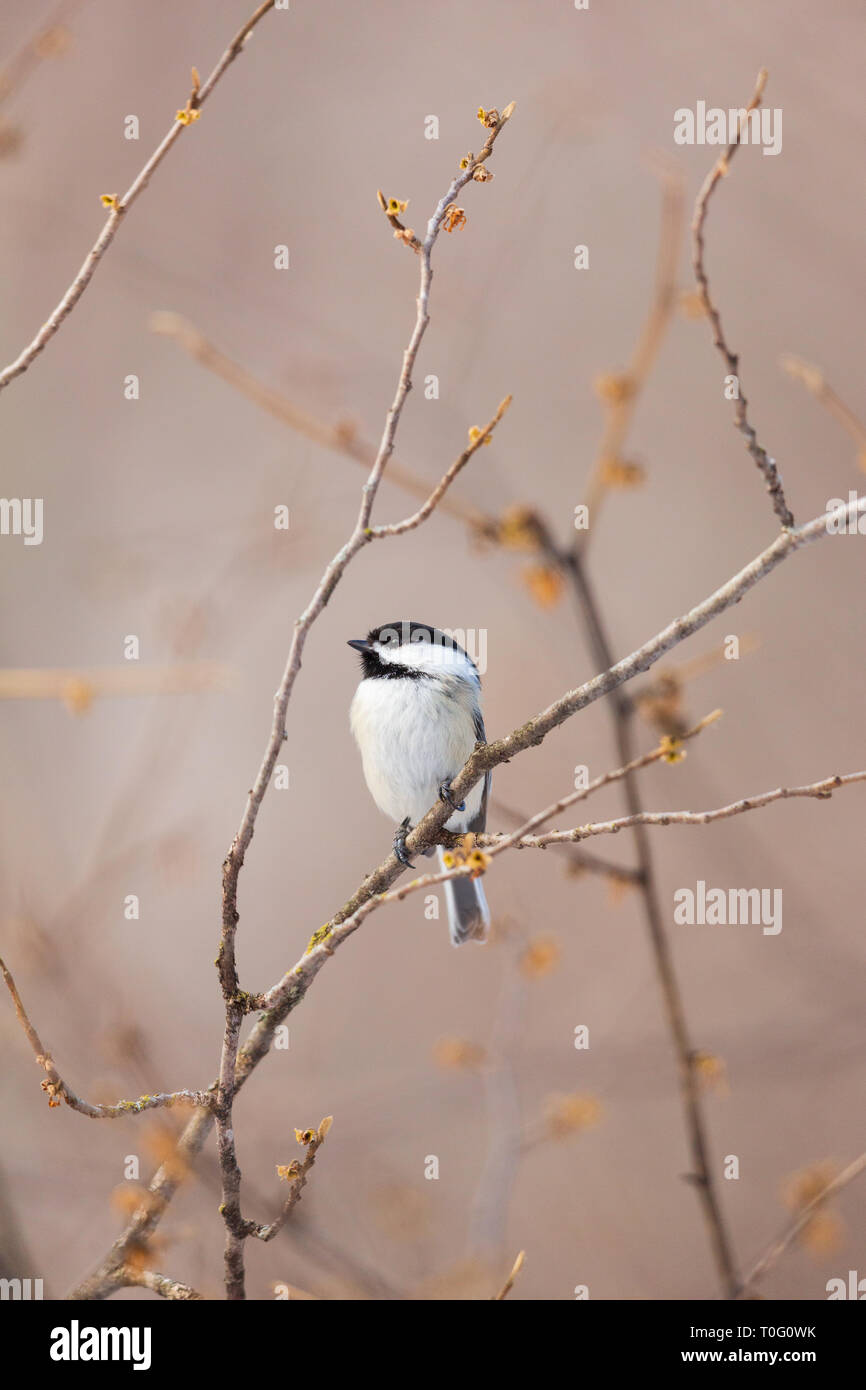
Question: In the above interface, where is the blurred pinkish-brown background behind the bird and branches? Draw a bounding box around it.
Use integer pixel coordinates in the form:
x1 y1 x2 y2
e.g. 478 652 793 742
0 0 866 1300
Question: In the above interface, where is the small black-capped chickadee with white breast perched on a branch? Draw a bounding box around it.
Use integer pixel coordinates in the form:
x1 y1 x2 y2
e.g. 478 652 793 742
349 620 491 947
